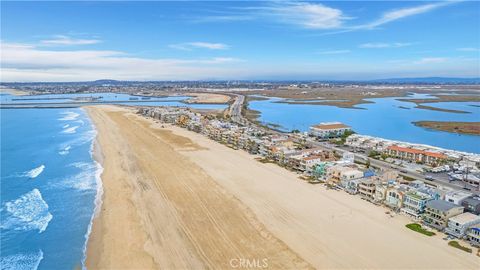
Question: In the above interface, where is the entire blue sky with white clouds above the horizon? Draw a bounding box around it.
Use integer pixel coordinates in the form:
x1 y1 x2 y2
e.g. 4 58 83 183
1 1 480 81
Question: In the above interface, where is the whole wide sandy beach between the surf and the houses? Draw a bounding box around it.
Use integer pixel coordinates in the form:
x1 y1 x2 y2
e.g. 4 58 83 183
86 106 480 269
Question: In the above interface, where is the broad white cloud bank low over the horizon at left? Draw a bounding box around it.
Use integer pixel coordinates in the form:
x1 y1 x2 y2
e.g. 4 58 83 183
0 42 243 81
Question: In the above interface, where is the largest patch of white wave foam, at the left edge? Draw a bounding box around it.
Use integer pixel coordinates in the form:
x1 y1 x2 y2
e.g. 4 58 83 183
1 189 53 233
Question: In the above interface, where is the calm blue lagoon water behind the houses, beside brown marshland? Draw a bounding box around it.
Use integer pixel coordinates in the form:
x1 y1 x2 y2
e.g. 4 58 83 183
249 94 480 153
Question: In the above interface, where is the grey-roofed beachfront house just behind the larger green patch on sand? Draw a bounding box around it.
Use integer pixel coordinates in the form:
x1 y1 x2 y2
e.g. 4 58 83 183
423 200 463 231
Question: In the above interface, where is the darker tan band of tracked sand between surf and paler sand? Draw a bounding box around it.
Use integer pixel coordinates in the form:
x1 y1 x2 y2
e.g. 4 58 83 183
87 107 310 269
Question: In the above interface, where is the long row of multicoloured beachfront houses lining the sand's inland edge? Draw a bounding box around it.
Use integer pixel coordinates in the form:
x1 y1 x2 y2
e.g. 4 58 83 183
139 107 480 249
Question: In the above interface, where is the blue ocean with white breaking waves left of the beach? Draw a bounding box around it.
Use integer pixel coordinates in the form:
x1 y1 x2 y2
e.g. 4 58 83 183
0 109 102 269
